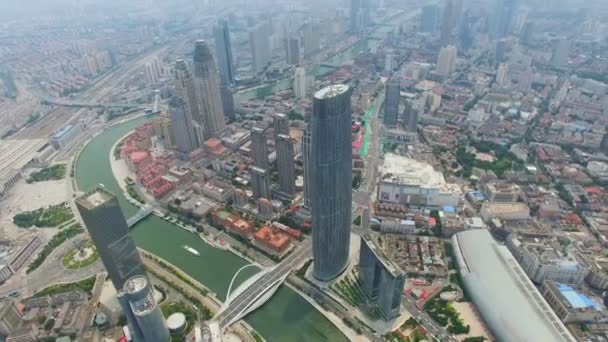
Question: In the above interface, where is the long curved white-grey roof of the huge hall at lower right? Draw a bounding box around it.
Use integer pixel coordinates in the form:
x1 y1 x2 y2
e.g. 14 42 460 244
452 229 576 342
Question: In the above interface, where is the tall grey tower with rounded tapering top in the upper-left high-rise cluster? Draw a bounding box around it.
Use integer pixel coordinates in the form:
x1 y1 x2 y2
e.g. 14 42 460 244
194 40 226 139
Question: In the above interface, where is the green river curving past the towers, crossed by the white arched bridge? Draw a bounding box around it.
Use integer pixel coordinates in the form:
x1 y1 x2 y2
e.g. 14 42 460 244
76 118 347 342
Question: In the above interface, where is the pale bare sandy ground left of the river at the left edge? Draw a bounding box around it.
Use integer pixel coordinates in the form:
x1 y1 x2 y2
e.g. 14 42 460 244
0 176 67 240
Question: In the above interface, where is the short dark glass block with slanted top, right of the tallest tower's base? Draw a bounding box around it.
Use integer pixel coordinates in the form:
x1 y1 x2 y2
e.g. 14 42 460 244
359 235 405 320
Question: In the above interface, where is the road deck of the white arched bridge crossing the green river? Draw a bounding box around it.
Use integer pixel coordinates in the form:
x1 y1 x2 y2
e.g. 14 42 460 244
215 240 312 329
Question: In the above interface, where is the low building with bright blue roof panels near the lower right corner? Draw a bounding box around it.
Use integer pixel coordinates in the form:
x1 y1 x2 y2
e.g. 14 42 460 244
541 280 608 323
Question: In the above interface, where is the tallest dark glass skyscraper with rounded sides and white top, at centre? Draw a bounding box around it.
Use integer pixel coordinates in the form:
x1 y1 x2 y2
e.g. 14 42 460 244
309 84 352 281
